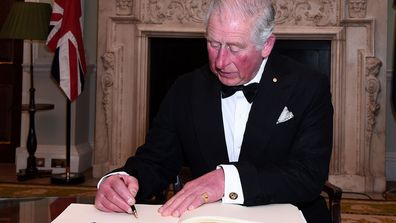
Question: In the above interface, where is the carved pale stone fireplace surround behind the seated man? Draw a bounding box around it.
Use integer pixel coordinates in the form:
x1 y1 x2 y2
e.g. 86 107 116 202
93 0 387 192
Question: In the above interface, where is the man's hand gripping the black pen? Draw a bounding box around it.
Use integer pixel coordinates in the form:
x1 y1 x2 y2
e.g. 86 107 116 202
95 174 139 213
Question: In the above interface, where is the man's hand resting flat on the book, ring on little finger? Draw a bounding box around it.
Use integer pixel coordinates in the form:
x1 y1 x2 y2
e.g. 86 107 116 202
158 168 224 217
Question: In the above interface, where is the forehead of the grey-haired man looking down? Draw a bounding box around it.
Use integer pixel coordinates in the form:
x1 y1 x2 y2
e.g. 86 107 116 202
206 13 251 42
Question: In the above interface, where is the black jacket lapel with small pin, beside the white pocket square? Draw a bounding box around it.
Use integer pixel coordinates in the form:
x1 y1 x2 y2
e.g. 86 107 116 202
239 56 295 161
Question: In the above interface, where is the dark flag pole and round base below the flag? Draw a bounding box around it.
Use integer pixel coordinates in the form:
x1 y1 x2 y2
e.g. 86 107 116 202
51 98 85 184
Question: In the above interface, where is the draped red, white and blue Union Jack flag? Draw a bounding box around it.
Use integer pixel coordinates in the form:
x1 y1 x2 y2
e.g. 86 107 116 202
47 0 87 101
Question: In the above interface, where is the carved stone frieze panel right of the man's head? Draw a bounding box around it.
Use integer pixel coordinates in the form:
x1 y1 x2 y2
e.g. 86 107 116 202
274 0 337 26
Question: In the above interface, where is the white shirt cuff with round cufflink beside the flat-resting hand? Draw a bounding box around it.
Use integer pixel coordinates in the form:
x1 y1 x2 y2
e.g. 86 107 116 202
217 165 244 204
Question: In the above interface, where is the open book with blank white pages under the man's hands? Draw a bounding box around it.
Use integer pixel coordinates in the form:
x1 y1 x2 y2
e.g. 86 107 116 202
52 203 306 223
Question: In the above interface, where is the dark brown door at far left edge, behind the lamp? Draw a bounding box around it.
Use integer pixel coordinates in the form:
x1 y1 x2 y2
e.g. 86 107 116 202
0 0 23 163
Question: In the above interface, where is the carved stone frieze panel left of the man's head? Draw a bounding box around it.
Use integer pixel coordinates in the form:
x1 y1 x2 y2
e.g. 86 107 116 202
144 0 209 24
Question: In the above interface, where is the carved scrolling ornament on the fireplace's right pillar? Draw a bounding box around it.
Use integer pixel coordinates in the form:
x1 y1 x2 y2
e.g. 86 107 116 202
366 57 382 148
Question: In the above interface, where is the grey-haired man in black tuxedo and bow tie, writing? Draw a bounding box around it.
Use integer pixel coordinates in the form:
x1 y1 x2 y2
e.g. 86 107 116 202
95 0 333 223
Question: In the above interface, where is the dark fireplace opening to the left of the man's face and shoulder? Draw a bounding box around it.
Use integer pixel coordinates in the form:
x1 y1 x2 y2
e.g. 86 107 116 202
149 38 208 124
